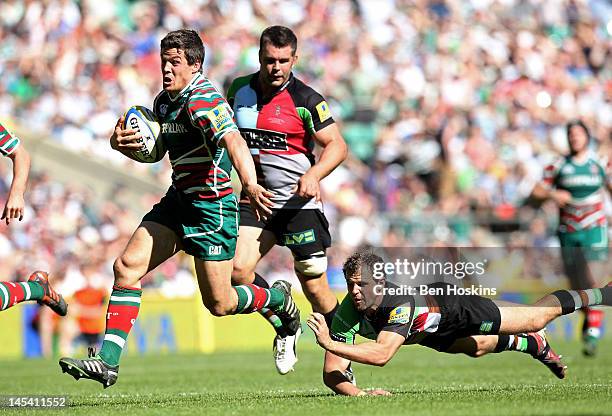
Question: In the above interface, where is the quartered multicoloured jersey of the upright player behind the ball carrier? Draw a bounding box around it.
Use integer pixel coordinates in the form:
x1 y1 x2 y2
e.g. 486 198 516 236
227 72 334 210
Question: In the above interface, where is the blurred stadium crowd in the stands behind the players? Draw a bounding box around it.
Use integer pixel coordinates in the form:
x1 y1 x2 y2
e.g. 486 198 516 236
0 0 612 300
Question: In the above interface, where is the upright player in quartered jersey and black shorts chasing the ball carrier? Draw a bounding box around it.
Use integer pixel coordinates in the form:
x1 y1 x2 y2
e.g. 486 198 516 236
228 26 347 374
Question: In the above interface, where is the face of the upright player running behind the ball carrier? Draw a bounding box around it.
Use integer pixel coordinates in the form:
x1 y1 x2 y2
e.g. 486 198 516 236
259 43 297 88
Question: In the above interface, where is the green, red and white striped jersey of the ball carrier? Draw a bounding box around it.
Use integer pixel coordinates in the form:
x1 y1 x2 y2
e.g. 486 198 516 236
153 73 238 200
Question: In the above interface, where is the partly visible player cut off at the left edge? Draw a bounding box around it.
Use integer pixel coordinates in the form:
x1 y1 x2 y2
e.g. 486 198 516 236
0 124 67 316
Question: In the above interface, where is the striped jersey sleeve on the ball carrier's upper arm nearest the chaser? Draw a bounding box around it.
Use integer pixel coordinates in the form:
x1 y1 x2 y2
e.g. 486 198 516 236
187 84 238 145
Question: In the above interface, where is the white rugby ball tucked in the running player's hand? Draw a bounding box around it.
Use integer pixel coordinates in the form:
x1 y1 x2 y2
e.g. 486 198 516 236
123 105 166 163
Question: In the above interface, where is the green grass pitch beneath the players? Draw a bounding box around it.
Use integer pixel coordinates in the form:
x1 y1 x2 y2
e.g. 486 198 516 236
0 339 612 416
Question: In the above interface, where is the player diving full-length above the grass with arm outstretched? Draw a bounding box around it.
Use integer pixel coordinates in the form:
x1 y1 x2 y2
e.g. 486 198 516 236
307 252 612 396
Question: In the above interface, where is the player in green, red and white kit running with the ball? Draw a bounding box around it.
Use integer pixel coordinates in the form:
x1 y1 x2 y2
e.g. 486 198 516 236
60 30 299 388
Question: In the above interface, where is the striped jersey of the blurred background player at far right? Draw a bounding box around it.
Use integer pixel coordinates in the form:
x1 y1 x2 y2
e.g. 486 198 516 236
543 156 612 232
